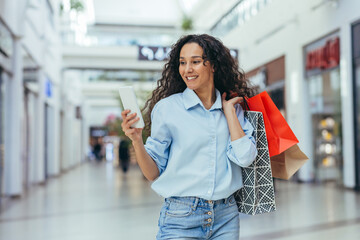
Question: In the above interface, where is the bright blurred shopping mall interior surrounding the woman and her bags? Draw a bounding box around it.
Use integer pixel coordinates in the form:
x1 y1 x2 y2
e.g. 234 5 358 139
0 0 360 240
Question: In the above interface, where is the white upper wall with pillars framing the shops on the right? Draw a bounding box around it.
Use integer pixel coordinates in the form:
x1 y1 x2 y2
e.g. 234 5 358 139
223 0 360 187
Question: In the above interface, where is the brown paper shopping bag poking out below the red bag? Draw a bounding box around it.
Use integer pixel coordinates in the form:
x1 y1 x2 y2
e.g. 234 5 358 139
270 144 309 180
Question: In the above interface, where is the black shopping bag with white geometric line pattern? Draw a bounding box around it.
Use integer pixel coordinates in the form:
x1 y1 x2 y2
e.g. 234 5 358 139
234 111 276 215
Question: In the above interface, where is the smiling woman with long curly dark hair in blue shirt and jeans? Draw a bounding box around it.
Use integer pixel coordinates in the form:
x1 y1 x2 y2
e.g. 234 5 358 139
122 34 257 240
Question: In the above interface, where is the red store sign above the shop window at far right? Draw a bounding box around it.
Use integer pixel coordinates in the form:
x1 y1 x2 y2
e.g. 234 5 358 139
306 37 340 71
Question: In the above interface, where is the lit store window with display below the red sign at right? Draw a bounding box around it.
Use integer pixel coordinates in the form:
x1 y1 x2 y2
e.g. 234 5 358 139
308 69 342 181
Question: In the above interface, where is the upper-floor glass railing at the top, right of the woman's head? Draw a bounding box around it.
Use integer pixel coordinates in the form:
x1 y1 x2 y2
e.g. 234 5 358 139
211 0 272 37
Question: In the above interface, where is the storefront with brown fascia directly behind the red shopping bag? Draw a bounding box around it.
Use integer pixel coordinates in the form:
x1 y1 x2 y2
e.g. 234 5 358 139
246 56 286 117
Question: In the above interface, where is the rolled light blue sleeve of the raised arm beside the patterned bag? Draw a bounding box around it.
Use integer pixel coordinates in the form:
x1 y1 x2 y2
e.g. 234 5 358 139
227 104 257 167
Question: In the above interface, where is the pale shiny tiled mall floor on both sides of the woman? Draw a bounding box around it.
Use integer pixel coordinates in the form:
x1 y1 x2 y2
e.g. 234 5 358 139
0 163 360 240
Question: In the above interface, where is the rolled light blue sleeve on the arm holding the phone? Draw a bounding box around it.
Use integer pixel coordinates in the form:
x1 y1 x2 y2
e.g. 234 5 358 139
145 102 171 175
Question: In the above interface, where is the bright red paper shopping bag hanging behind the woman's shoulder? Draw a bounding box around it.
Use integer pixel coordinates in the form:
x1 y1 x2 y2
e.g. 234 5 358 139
247 92 299 157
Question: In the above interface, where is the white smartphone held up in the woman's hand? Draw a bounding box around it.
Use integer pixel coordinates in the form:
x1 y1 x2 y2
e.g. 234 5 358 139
119 86 145 128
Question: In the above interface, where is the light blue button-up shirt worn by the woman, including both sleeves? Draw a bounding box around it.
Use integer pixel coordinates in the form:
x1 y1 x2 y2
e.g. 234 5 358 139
145 88 257 200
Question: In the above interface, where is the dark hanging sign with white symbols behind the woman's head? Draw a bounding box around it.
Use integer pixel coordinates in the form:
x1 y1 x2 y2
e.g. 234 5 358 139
138 46 239 61
